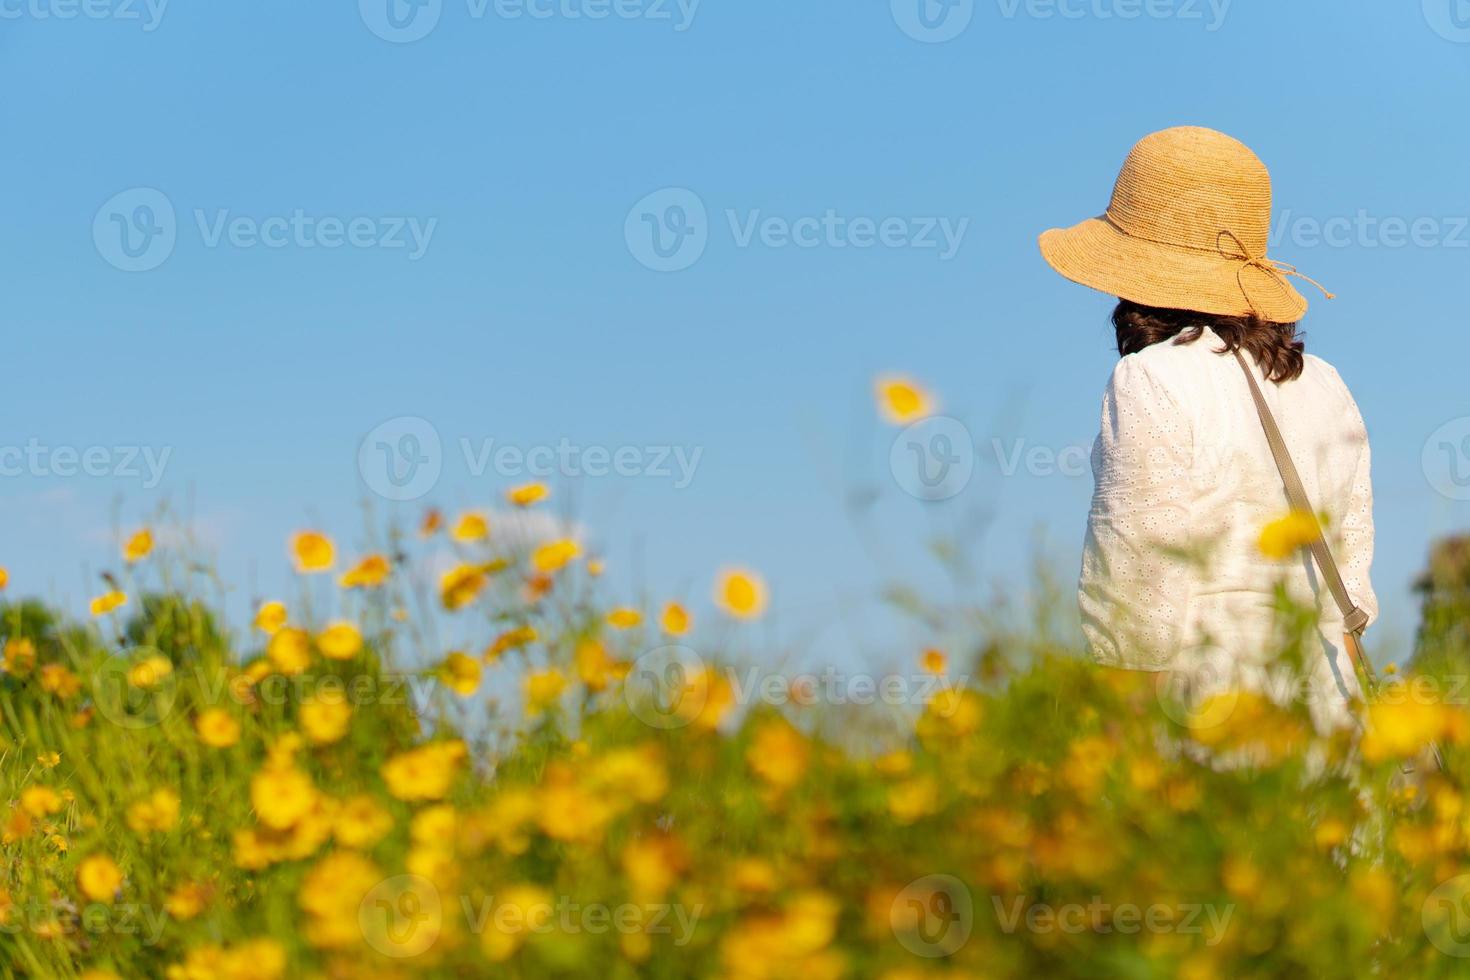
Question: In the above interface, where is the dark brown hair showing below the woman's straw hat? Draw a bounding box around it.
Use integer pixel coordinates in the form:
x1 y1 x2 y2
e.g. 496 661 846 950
1113 300 1307 385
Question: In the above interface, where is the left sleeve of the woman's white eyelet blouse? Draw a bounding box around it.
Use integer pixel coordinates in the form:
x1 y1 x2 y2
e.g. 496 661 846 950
1078 357 1194 670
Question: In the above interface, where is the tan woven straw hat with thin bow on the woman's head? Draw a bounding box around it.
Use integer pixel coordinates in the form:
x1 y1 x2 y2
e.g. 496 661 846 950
1041 126 1333 323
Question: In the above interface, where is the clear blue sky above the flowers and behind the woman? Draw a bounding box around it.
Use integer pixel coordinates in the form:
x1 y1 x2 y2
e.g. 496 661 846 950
0 0 1470 669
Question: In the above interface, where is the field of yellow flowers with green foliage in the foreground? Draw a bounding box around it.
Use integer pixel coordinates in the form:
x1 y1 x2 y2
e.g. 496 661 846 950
0 382 1470 980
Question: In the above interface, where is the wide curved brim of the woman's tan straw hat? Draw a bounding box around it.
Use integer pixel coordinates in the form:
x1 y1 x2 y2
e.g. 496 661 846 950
1039 216 1307 323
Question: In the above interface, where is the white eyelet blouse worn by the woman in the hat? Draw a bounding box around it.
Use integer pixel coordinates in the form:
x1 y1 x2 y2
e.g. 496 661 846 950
1078 329 1377 723
